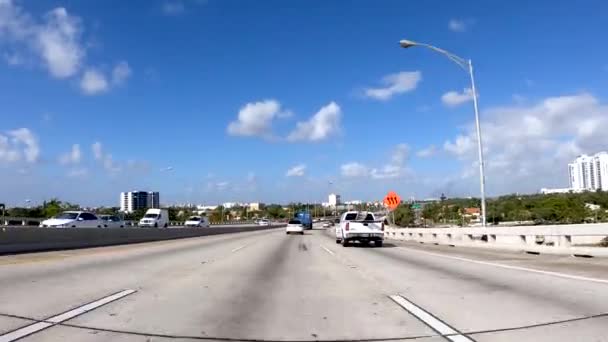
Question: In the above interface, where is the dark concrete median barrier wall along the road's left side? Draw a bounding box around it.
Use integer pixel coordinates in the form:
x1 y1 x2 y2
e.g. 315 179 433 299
0 225 284 254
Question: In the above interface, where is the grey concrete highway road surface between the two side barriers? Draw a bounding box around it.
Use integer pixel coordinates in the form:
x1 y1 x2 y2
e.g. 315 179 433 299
0 229 608 342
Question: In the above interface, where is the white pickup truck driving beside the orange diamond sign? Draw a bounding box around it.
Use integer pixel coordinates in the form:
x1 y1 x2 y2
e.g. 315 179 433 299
336 211 384 247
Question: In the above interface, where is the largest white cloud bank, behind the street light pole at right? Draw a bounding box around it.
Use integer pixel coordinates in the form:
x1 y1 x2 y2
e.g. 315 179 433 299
443 93 608 192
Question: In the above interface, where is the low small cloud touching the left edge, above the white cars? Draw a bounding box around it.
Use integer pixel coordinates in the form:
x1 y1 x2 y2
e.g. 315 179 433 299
0 128 40 163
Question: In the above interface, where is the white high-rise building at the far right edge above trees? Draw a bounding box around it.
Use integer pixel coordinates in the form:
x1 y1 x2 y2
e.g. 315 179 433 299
568 152 608 191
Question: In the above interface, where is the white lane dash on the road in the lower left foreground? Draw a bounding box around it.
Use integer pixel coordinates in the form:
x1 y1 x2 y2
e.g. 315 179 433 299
0 290 135 342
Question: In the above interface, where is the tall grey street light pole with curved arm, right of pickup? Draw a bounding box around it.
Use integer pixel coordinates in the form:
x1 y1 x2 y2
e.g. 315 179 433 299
399 39 487 228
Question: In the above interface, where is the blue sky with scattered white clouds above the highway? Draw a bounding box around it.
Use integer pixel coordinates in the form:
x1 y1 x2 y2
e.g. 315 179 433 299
0 0 608 205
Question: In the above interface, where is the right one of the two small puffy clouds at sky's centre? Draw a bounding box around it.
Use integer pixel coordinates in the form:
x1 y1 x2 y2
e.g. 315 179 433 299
287 101 341 141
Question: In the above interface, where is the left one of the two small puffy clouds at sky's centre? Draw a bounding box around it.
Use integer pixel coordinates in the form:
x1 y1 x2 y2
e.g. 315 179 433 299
227 100 281 138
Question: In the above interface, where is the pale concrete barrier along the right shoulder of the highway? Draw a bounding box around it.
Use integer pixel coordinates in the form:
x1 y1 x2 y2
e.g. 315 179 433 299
384 223 608 257
